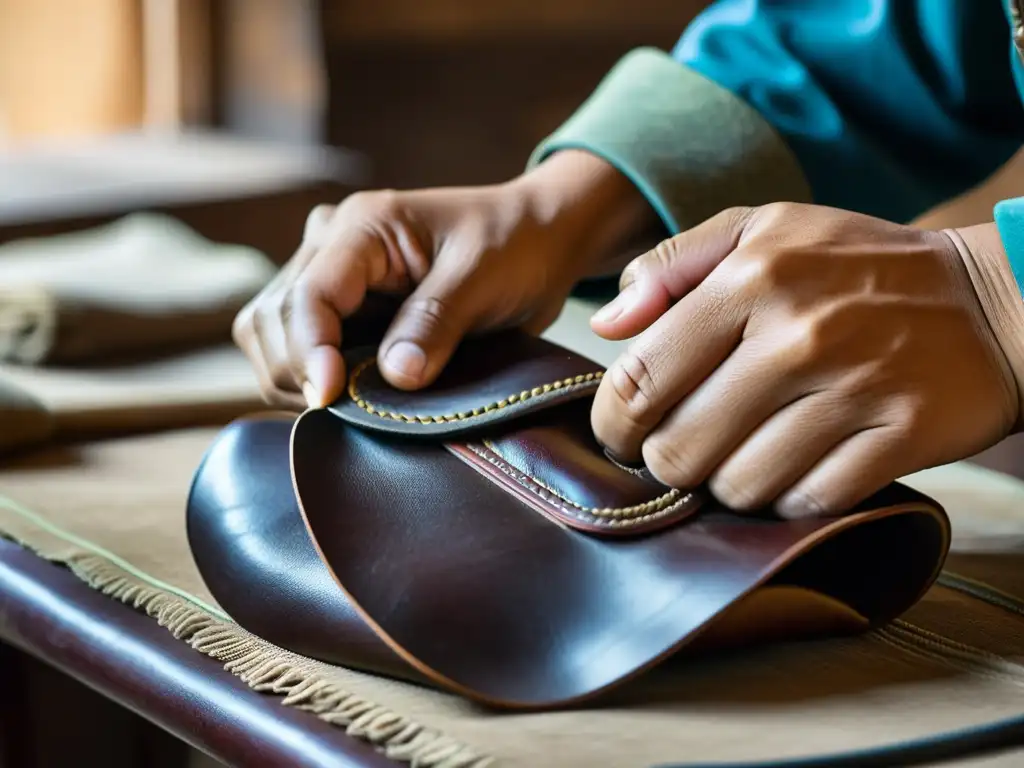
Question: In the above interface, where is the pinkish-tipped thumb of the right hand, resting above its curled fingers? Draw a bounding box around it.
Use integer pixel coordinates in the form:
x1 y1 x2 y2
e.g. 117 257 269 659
591 208 757 340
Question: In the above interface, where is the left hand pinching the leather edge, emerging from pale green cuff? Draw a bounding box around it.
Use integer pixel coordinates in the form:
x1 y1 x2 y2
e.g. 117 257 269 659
232 152 652 410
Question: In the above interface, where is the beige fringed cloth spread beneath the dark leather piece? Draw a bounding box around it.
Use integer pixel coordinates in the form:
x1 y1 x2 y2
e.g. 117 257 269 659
0 429 1024 768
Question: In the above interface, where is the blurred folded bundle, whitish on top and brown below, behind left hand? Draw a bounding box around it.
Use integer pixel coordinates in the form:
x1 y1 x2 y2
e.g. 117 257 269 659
0 213 275 366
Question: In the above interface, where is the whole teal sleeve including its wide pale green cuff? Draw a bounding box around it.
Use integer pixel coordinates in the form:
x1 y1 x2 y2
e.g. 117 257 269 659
530 0 1024 231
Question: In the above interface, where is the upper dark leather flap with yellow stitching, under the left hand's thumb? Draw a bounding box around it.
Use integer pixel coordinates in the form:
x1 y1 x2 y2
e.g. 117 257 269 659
329 332 603 438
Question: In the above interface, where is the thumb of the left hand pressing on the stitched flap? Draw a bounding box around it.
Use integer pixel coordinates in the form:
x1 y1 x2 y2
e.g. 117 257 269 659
378 267 480 390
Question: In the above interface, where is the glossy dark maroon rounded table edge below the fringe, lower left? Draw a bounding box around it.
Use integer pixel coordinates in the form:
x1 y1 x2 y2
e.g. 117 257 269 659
0 541 394 768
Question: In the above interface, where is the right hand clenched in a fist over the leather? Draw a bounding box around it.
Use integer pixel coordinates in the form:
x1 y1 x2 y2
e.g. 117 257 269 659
593 204 1021 516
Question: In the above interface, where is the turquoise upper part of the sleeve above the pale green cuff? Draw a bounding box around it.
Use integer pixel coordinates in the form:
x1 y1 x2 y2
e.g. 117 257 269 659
673 0 1024 221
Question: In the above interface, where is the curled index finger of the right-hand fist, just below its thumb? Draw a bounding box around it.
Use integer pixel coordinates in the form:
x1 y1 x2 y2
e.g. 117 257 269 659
591 280 748 463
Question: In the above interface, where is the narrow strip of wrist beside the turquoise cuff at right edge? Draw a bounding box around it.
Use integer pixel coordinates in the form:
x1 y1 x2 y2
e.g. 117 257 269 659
945 223 1024 431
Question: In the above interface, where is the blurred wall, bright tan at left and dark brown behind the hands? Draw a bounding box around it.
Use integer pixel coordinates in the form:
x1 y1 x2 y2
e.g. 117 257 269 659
0 0 707 187
